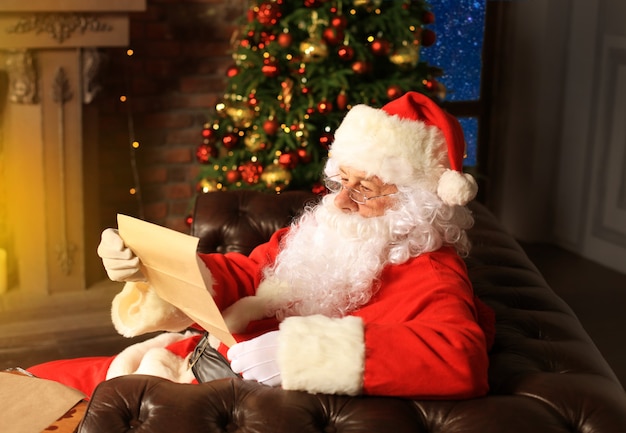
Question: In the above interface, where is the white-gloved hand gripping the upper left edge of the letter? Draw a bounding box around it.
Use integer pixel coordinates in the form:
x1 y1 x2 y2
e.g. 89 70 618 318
98 229 146 281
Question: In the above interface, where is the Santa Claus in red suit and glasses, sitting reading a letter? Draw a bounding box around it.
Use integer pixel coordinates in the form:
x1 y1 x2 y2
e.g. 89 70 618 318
30 92 493 399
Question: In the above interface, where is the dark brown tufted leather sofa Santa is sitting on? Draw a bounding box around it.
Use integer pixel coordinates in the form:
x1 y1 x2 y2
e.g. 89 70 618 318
79 191 626 433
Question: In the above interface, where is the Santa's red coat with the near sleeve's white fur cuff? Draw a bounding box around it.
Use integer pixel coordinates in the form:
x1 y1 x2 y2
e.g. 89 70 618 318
202 229 493 398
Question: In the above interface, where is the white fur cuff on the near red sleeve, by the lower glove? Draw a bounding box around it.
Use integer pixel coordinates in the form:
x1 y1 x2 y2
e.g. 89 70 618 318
278 315 365 395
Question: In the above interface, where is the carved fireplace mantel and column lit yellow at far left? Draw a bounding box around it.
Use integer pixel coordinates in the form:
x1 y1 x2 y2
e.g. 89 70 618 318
0 0 146 311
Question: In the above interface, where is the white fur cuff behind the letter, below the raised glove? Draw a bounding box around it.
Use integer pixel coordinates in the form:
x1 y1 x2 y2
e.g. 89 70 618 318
111 282 193 337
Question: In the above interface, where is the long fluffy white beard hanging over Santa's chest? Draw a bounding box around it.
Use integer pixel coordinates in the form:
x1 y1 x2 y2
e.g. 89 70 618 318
257 196 393 320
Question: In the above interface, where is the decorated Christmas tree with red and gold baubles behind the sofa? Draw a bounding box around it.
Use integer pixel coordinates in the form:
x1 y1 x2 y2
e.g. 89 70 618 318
196 0 445 192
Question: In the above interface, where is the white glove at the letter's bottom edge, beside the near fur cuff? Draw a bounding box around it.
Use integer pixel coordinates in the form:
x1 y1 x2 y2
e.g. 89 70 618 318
227 331 282 386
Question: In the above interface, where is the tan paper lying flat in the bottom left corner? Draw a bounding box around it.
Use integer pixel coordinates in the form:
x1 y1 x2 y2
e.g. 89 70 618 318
0 372 85 433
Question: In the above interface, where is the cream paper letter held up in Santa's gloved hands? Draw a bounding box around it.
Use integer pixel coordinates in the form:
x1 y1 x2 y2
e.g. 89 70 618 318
117 214 236 347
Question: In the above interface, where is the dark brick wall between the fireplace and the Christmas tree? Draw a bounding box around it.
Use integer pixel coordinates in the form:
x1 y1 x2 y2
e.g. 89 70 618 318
94 0 247 231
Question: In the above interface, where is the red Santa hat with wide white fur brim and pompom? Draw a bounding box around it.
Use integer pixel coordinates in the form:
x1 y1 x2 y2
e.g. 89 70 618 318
326 92 478 206
